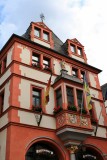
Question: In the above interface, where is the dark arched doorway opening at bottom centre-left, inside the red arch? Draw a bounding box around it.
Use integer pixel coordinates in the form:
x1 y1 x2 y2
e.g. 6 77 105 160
25 142 59 160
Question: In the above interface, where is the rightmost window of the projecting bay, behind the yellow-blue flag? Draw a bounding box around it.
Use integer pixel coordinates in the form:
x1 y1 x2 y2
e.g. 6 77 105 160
77 90 84 108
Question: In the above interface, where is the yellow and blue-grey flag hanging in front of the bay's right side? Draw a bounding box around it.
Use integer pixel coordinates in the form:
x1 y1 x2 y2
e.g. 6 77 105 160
83 73 92 110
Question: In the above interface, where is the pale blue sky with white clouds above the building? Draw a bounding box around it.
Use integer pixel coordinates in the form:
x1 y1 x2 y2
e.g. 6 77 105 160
0 0 107 85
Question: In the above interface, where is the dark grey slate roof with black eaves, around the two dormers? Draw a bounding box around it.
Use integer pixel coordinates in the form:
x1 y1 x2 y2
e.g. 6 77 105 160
0 22 102 73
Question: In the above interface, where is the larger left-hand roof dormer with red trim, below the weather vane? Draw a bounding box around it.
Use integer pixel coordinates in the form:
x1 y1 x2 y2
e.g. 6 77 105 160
30 22 54 49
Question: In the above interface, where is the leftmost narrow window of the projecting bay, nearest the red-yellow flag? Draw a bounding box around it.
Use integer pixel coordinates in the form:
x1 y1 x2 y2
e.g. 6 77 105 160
56 88 62 107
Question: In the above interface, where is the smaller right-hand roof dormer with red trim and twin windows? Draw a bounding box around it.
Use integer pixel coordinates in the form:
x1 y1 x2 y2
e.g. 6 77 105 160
67 38 87 63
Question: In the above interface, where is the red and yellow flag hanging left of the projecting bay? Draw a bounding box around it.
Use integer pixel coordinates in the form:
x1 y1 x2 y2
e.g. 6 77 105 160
44 73 52 105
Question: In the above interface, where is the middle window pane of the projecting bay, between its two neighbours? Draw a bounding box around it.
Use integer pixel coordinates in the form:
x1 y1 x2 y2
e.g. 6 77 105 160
66 87 74 106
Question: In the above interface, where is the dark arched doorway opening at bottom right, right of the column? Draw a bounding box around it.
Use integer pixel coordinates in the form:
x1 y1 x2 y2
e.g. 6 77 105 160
76 145 104 160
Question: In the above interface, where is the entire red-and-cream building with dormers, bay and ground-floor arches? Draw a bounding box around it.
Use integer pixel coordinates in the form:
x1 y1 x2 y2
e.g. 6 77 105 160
0 22 107 160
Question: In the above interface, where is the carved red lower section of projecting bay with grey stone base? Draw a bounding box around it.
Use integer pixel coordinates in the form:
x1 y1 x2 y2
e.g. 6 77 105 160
55 110 93 143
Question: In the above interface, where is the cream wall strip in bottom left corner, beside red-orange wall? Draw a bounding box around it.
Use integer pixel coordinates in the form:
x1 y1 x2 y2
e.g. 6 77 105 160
0 129 7 160
